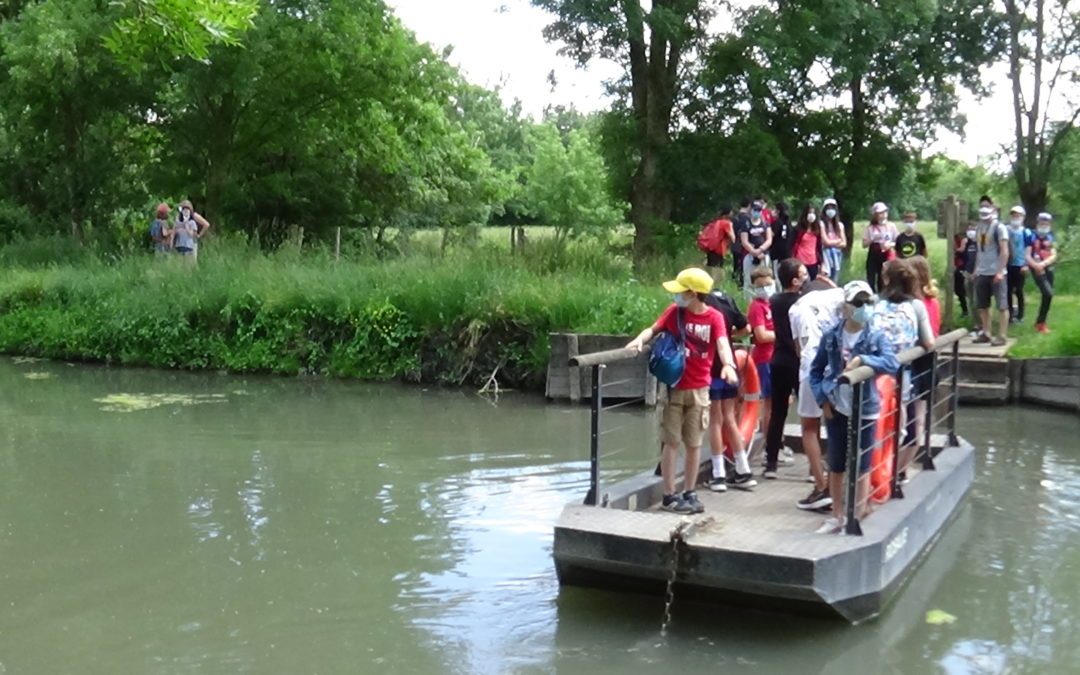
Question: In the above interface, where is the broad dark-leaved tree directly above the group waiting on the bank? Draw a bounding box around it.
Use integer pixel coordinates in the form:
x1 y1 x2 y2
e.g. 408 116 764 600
690 0 997 241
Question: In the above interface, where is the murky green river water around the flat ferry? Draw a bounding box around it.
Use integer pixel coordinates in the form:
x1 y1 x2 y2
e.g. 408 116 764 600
0 357 1080 675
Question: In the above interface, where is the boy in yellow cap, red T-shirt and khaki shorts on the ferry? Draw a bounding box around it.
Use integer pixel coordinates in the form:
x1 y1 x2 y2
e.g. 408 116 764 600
626 268 738 513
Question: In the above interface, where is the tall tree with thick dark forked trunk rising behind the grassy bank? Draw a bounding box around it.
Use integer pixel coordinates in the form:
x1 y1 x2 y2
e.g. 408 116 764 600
531 0 712 259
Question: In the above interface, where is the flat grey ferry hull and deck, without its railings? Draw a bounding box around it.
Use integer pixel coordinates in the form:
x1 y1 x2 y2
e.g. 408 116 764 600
553 435 974 622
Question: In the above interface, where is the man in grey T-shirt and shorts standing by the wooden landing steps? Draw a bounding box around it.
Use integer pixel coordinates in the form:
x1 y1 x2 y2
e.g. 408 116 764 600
975 206 1009 347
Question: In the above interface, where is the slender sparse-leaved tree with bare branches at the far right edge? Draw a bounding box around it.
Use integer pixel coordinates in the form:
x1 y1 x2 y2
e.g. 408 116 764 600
1004 0 1080 225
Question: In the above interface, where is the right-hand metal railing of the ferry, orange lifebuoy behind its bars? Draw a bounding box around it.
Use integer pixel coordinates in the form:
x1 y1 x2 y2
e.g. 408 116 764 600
833 329 966 535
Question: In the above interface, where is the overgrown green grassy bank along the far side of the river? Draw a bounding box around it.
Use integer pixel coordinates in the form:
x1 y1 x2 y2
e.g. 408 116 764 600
0 224 1080 389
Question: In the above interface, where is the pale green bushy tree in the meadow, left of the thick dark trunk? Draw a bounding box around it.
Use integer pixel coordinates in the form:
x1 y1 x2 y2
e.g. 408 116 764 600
526 124 624 241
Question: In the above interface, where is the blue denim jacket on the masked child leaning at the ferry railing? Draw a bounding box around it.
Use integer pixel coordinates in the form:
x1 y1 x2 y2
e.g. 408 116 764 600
810 321 900 419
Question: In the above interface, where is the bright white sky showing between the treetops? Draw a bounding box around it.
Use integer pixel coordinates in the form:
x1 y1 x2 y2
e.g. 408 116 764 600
388 0 1013 168
